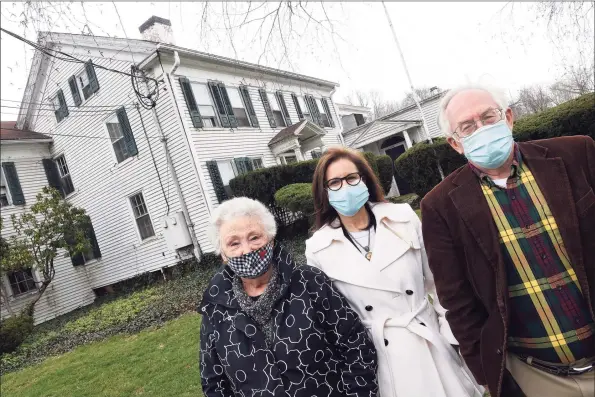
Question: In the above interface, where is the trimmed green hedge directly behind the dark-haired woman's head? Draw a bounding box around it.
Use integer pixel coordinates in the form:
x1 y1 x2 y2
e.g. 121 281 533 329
229 153 393 204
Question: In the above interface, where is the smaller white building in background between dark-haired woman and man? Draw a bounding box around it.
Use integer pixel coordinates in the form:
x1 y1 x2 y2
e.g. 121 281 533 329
343 92 444 194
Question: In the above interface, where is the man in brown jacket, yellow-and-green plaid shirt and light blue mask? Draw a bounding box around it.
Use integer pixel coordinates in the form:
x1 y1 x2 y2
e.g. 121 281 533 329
421 87 595 397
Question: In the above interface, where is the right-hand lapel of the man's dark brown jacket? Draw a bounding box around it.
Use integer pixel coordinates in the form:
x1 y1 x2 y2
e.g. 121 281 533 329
519 143 583 276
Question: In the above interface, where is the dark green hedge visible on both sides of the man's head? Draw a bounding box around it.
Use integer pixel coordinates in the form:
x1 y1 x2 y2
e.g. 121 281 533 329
395 93 595 197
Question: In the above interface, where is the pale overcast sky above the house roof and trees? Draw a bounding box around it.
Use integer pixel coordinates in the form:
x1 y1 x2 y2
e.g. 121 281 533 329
1 2 593 120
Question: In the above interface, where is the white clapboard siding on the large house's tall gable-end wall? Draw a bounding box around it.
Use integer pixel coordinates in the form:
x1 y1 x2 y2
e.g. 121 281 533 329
26 44 200 288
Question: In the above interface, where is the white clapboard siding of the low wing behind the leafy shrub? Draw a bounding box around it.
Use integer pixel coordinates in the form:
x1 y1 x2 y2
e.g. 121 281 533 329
0 143 95 324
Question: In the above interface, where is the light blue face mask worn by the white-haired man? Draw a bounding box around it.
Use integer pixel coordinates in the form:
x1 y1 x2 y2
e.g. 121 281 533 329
461 120 514 170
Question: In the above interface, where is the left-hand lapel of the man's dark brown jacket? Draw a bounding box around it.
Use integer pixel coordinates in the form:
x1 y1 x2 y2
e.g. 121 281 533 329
449 166 502 271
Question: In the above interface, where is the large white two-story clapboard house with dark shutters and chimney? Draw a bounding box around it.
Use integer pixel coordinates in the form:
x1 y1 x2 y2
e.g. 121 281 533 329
2 17 342 322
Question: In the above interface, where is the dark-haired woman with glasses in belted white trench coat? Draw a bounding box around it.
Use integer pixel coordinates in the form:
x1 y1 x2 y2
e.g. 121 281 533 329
306 148 483 397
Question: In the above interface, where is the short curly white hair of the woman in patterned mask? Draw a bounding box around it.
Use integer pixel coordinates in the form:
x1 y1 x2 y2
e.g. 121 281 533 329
207 197 277 253
